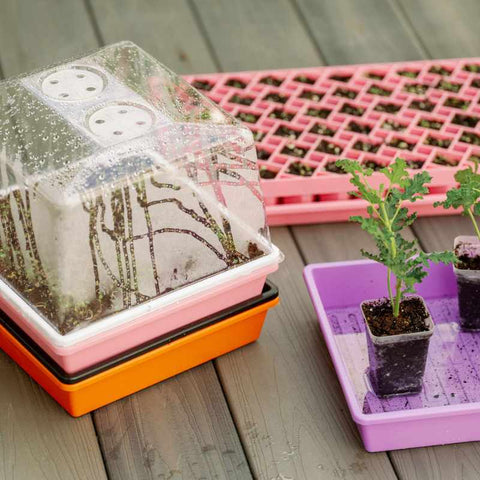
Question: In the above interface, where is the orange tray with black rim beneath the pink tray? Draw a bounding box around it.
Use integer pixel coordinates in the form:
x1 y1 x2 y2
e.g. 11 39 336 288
0 282 279 417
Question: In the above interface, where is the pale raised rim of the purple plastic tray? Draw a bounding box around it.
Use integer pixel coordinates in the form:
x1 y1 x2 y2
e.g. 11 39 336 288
303 260 480 427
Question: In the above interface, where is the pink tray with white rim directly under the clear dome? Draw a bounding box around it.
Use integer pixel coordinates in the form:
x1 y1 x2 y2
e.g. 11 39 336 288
0 247 282 374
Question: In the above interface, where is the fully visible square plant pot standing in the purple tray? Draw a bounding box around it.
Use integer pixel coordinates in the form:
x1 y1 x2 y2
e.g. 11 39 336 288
361 295 434 397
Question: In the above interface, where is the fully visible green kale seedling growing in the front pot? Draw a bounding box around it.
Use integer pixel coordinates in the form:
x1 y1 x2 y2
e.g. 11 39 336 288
336 158 455 318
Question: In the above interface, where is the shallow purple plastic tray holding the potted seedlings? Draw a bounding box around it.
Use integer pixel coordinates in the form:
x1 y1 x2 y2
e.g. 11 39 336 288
304 260 480 452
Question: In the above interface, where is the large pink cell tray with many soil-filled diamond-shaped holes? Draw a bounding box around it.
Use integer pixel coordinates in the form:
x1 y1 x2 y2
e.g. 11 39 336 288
185 58 480 225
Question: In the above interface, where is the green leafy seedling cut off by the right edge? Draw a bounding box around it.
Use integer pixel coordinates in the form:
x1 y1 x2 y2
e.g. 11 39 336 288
434 159 480 240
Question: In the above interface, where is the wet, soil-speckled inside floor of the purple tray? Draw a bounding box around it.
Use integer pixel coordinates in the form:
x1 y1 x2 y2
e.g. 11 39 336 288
327 297 480 414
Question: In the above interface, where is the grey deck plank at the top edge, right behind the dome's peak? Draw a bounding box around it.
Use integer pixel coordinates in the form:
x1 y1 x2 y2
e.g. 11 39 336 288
87 0 216 73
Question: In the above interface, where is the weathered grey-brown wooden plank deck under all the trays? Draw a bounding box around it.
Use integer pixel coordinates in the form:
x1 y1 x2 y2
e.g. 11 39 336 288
0 0 480 480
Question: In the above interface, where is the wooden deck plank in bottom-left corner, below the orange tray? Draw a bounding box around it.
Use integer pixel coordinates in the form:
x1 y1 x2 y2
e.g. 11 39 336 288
0 352 107 480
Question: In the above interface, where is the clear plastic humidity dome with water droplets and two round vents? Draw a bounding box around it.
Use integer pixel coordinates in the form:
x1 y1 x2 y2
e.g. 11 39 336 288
0 42 272 334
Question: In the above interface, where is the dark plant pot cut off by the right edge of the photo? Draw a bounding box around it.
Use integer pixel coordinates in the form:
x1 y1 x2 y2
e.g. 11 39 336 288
453 235 480 331
